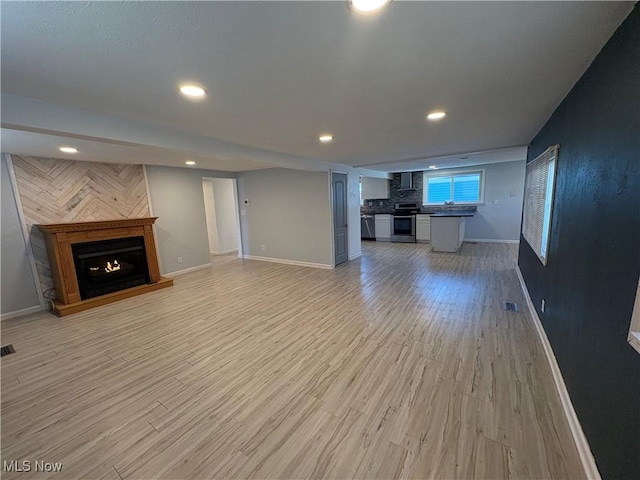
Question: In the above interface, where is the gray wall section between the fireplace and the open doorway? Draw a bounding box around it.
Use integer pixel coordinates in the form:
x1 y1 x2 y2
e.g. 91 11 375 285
146 165 235 274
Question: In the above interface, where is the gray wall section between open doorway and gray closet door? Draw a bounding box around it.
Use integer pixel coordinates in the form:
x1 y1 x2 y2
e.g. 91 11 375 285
238 168 333 265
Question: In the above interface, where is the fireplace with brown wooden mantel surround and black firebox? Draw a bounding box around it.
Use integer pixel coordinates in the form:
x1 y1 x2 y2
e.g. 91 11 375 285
38 217 173 316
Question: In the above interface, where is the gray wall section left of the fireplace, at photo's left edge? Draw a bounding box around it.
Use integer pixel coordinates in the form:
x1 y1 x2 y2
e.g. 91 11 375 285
0 154 40 314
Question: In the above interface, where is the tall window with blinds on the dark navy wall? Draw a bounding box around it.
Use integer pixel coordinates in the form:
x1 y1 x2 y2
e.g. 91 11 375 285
522 145 558 265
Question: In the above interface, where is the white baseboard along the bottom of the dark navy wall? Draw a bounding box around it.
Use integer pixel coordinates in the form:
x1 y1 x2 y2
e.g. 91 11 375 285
516 266 602 480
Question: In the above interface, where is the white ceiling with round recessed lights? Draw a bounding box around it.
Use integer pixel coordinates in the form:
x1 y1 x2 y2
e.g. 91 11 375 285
1 1 633 171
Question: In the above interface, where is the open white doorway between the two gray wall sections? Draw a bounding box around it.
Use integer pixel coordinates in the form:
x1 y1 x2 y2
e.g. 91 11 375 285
202 177 242 260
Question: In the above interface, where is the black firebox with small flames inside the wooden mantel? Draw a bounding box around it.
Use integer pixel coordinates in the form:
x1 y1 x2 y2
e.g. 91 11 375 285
71 237 149 300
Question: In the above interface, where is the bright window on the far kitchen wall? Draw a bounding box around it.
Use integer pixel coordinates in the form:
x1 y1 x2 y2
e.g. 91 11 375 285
422 171 484 205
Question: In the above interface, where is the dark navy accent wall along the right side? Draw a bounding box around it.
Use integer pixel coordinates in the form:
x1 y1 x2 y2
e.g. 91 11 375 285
518 4 640 479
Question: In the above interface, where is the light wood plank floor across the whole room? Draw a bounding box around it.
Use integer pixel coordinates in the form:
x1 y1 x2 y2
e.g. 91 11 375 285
2 242 583 480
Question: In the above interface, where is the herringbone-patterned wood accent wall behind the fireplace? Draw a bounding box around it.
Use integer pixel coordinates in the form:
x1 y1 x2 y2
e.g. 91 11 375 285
11 155 150 299
